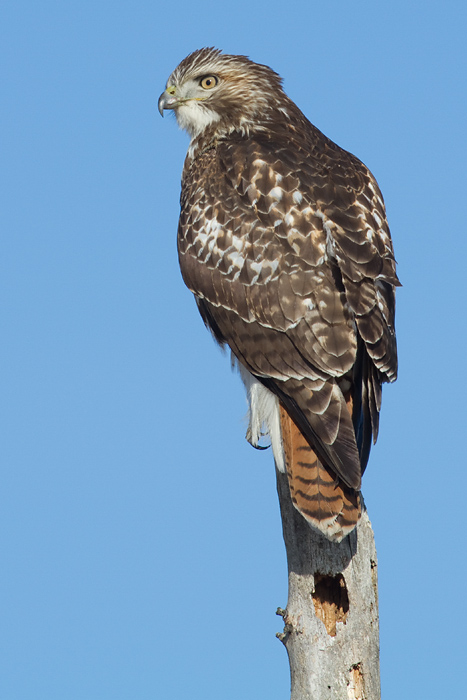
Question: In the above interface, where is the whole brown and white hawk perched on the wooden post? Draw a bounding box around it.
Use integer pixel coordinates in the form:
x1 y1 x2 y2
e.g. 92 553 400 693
159 48 399 541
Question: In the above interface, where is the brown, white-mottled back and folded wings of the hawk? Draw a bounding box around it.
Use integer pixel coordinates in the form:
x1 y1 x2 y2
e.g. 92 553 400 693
178 117 398 489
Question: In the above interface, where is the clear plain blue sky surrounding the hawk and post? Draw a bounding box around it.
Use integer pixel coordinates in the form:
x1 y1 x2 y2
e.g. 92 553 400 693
0 0 467 700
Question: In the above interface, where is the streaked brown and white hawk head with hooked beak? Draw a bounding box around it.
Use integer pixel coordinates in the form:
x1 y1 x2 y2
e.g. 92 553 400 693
159 48 290 138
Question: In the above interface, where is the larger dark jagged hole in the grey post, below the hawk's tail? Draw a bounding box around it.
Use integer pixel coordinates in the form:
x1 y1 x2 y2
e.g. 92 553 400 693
312 574 349 637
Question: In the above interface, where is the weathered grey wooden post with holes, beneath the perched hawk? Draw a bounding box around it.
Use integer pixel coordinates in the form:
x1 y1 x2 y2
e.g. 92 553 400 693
277 464 381 700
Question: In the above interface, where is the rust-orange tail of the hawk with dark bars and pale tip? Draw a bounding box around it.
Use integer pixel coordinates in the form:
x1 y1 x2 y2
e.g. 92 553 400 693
280 406 361 542
